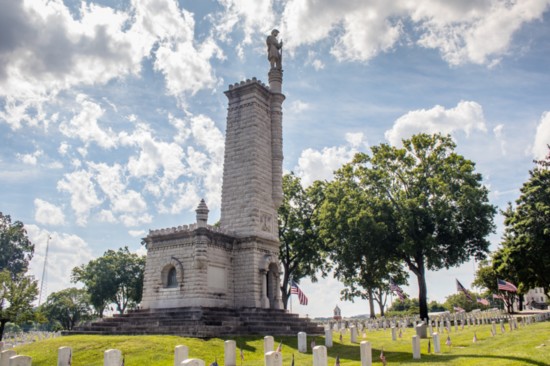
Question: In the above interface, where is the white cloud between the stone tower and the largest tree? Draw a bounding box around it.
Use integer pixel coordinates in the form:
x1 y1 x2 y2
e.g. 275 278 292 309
294 133 367 186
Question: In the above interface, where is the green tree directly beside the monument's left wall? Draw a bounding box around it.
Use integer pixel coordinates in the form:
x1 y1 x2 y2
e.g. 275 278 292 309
72 247 145 317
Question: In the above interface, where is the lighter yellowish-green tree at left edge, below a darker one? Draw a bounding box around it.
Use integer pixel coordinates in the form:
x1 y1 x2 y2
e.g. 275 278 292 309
0 269 38 341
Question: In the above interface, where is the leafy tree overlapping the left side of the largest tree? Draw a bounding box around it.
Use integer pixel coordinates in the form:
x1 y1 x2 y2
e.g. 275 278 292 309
319 172 405 317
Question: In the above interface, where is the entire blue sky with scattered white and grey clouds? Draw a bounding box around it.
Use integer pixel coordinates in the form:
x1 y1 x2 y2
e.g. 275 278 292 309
0 0 550 316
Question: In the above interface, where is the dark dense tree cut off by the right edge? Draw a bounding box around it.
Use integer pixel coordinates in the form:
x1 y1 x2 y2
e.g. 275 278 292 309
494 147 550 296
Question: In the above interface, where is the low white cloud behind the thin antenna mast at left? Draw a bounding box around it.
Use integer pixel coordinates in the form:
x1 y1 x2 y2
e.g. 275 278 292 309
25 225 93 302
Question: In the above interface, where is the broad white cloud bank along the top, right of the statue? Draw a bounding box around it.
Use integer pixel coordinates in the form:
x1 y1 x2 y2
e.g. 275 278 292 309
281 0 550 65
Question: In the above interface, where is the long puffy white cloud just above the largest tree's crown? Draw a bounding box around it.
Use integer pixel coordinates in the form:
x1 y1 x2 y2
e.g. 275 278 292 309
384 101 487 145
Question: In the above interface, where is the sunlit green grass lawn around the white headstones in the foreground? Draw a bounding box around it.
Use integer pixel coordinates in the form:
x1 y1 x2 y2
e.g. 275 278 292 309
11 321 550 366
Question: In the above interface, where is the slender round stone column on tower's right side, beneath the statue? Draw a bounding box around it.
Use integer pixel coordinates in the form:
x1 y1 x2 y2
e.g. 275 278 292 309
268 69 285 210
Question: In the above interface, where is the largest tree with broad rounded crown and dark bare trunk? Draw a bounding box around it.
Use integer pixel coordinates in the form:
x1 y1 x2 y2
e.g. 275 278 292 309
326 134 495 318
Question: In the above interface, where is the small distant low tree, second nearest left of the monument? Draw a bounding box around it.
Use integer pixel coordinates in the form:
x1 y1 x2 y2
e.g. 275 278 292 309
41 287 91 330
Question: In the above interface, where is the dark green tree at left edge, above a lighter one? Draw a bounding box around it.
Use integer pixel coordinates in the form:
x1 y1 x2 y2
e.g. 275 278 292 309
0 212 34 278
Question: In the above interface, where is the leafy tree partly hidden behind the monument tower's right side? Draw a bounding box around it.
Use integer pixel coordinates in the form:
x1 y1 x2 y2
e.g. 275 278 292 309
278 173 323 309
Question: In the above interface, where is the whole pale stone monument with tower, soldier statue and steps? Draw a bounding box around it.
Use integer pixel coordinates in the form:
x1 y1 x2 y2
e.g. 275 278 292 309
72 30 323 337
